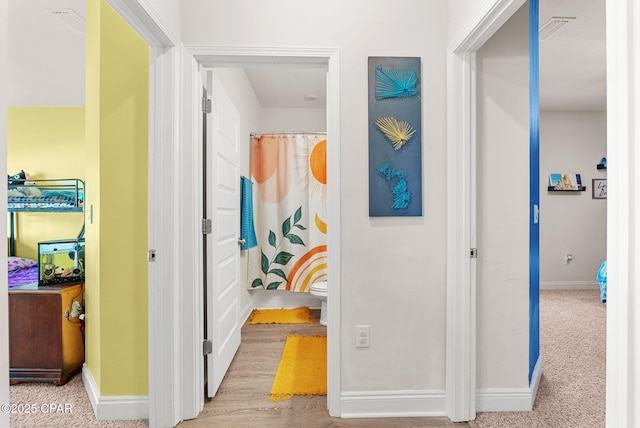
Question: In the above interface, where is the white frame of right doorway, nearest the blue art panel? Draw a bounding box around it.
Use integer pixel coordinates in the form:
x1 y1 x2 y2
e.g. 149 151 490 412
445 0 526 422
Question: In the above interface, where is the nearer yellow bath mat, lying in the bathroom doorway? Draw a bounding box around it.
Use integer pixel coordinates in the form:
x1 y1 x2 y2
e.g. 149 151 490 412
269 335 327 401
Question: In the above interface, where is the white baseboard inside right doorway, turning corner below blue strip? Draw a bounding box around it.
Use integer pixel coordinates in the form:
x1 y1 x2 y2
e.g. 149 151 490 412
476 357 542 412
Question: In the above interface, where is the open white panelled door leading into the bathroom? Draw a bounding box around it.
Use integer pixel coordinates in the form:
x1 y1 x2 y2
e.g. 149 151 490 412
205 71 241 397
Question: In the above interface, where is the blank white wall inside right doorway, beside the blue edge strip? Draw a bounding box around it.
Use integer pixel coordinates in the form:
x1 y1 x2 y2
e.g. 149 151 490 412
476 5 529 389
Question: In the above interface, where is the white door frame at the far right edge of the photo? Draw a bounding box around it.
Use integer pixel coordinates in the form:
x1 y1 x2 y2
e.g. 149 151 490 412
606 0 640 427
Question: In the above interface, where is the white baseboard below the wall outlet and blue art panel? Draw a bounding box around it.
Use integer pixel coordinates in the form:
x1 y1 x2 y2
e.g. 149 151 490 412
340 390 445 418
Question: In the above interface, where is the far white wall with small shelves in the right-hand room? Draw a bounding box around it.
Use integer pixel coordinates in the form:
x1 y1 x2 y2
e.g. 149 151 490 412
540 111 607 289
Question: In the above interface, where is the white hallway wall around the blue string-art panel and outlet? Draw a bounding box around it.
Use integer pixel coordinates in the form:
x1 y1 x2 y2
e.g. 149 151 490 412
182 0 447 392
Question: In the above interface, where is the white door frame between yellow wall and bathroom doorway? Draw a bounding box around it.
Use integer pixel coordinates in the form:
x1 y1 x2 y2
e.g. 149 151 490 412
105 0 184 427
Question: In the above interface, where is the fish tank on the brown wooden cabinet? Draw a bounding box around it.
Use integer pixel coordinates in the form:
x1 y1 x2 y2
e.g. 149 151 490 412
38 239 84 286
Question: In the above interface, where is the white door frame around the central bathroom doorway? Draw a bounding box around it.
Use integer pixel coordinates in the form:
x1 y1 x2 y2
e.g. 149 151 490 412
180 45 341 417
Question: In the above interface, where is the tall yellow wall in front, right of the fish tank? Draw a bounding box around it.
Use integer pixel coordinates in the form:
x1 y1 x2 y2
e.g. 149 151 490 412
85 0 149 396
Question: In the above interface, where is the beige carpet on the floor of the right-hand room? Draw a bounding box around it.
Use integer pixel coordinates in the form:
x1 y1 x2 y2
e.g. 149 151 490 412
476 290 606 428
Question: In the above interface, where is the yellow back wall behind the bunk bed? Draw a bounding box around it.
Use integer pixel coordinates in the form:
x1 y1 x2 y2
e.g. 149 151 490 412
7 107 86 260
